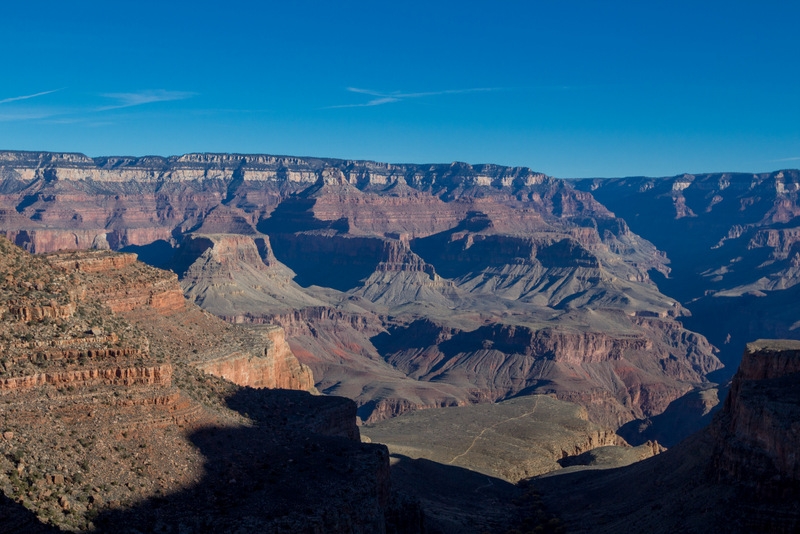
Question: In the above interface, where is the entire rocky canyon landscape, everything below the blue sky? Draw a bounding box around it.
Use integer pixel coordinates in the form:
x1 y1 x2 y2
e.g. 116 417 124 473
0 152 800 533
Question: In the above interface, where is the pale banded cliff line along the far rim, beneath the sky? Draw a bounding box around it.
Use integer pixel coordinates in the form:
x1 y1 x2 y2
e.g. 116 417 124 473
0 151 551 188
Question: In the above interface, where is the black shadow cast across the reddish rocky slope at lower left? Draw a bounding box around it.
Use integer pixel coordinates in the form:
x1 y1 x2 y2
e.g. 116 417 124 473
95 388 421 534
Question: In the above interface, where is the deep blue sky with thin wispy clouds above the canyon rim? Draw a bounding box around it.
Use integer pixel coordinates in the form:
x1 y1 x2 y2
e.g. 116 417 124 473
0 0 800 177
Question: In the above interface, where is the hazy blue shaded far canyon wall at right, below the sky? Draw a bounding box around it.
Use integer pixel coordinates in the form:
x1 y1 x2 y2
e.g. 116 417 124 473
573 170 800 383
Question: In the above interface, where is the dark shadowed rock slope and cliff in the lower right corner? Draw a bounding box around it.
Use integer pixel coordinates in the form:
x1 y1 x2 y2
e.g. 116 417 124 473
532 340 800 533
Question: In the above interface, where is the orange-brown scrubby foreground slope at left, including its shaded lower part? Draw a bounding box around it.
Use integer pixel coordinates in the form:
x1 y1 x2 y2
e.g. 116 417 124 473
0 238 423 533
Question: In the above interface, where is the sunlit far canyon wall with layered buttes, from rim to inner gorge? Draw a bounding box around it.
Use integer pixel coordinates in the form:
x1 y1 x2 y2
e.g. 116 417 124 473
0 152 722 436
